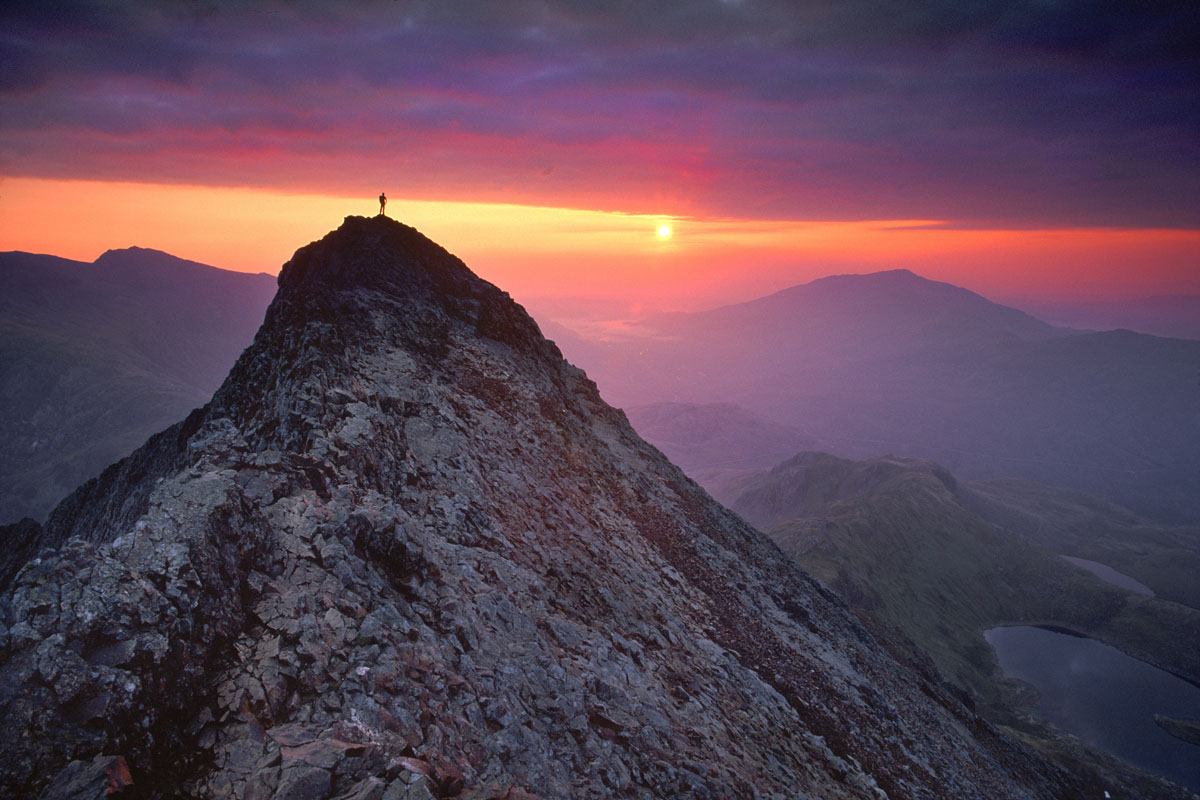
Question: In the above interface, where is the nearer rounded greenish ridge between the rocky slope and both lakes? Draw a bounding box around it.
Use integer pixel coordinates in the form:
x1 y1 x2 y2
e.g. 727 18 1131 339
731 453 1200 796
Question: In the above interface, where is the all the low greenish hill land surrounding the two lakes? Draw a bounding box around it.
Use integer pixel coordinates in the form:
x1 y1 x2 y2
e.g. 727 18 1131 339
730 452 1200 798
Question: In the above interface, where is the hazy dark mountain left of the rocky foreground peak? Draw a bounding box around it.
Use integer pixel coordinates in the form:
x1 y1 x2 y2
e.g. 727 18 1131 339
0 247 275 522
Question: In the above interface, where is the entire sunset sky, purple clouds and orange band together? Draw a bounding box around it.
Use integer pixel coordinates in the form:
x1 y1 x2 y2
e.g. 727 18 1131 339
0 0 1200 319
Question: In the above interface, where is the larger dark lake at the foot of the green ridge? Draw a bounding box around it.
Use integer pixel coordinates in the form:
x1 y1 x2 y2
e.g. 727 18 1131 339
984 626 1200 792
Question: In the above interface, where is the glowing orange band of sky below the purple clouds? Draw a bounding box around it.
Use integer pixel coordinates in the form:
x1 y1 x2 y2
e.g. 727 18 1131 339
0 179 1200 309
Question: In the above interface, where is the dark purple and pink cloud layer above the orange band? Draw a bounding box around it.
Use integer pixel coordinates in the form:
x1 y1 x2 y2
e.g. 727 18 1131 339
0 0 1200 225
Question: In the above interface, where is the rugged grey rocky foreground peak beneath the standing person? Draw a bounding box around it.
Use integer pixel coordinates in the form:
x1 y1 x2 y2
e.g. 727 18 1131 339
0 217 1088 800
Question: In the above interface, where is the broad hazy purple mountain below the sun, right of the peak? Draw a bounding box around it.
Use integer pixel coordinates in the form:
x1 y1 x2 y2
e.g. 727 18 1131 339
549 270 1200 522
